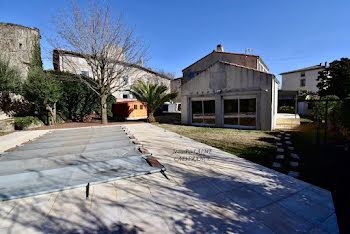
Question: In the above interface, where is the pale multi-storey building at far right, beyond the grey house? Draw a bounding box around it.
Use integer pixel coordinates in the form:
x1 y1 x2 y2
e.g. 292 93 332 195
280 63 327 94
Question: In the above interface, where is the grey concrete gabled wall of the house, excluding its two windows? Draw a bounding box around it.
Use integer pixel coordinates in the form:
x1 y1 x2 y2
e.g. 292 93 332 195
181 62 278 130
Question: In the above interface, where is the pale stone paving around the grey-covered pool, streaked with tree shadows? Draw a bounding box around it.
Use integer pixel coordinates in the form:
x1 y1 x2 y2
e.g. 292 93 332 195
0 124 338 233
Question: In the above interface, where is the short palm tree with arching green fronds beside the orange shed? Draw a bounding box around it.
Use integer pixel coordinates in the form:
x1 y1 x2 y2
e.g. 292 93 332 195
131 80 177 122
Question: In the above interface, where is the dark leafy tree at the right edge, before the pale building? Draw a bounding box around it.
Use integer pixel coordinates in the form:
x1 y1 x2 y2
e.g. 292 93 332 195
317 58 350 98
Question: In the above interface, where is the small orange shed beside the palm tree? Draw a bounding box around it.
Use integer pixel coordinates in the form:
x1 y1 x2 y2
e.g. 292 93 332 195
112 101 147 120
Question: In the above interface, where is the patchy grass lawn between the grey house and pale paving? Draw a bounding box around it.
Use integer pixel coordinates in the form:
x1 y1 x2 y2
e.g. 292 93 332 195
155 123 277 171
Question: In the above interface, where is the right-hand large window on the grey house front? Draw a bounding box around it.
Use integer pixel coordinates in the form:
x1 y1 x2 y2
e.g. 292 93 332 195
224 98 256 127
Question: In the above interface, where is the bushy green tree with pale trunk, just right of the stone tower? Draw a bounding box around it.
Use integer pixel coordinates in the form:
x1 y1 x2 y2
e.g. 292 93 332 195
23 43 62 124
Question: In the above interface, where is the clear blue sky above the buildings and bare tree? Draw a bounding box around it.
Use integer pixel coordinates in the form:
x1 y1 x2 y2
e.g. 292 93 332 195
0 0 350 82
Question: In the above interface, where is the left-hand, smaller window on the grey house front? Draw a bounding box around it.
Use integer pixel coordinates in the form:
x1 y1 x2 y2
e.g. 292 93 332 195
192 100 215 124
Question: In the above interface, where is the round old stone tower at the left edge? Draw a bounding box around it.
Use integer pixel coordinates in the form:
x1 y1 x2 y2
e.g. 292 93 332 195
0 22 40 80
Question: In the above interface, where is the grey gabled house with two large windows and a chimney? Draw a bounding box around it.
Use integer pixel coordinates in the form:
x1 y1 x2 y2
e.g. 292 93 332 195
181 45 278 130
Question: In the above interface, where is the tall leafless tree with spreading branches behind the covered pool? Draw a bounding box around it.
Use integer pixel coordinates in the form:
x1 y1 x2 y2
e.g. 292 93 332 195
49 1 146 124
